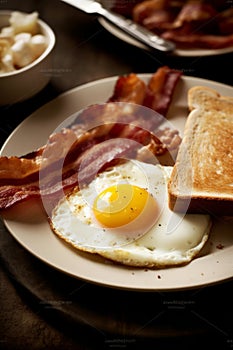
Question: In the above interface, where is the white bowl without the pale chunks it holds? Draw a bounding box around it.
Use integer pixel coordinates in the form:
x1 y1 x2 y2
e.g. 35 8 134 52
0 11 56 105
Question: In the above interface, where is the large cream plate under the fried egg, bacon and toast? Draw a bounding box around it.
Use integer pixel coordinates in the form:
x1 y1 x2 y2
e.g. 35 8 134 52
2 74 233 291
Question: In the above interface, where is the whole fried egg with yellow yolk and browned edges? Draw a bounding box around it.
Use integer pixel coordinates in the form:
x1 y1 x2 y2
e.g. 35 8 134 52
50 160 211 268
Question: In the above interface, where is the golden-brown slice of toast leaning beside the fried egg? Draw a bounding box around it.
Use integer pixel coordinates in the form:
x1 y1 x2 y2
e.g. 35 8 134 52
168 86 233 216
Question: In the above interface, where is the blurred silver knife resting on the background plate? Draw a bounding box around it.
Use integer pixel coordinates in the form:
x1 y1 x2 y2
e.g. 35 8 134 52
62 0 175 52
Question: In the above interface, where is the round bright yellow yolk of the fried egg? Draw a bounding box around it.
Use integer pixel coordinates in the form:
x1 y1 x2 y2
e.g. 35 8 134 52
93 184 155 228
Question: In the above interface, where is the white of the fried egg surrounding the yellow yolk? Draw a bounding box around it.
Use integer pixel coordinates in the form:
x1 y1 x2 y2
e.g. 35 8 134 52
50 161 211 268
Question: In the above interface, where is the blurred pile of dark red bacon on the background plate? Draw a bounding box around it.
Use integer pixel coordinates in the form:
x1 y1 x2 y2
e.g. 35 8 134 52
131 0 233 49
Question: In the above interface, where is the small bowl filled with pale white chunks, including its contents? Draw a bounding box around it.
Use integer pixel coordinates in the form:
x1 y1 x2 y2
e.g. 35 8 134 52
0 11 56 106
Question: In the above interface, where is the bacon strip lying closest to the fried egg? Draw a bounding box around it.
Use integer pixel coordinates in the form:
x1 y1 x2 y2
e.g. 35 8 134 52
0 129 169 210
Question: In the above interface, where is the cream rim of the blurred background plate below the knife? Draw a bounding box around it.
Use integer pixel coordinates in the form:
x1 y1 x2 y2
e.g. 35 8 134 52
98 17 233 57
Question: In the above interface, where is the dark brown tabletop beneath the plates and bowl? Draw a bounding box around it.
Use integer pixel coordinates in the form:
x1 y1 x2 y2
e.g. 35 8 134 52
0 0 233 350
